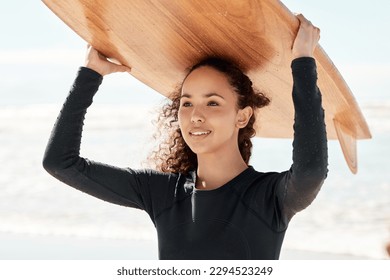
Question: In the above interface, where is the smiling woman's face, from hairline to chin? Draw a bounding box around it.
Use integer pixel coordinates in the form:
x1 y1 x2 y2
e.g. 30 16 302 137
178 66 248 155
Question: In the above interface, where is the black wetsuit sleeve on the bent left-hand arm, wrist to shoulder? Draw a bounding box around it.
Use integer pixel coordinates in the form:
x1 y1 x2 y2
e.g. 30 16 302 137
43 67 176 217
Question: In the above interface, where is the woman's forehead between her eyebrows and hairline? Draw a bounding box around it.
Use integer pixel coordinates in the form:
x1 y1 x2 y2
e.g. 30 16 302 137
181 66 235 95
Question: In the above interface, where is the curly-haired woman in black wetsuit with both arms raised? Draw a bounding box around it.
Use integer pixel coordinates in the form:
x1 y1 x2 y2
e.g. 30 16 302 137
43 15 327 259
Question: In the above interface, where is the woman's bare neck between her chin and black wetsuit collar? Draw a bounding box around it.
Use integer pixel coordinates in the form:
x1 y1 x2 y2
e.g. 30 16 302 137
196 148 248 190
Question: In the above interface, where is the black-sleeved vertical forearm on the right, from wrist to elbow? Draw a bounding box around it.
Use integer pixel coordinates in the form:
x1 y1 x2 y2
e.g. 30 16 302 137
292 58 328 177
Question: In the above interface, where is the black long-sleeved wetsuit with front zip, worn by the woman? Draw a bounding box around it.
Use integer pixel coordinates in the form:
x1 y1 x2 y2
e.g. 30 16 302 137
43 58 327 259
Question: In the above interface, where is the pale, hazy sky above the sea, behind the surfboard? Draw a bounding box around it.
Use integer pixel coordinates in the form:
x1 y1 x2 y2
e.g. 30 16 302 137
0 0 390 106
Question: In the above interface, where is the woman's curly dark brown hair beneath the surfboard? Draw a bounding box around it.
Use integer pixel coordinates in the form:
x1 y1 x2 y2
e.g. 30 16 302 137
149 57 270 174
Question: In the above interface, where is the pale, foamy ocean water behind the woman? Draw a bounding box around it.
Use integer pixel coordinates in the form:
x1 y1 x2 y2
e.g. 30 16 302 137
0 99 390 259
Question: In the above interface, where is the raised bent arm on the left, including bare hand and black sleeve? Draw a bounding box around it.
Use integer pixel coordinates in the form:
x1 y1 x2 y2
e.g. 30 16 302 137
43 47 152 209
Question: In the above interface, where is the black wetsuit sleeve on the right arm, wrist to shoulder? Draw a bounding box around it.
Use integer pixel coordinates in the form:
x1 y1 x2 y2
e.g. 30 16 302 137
279 57 328 220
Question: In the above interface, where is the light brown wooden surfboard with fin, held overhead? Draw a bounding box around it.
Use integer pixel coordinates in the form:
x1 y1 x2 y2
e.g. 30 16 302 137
43 0 371 173
